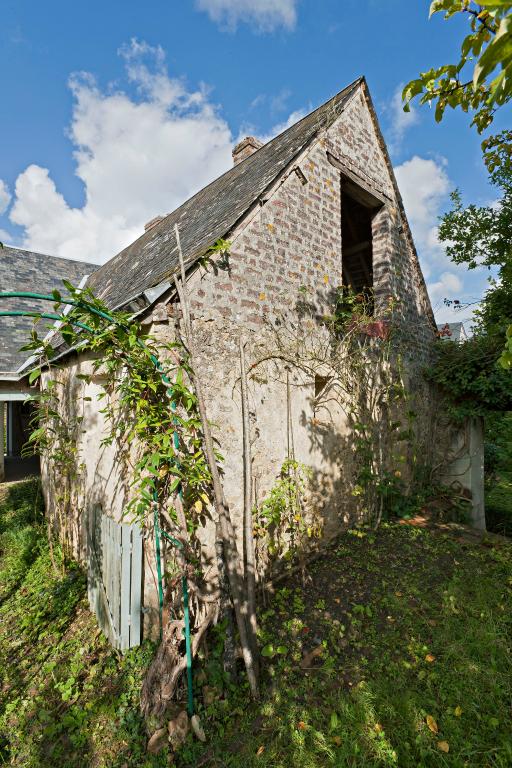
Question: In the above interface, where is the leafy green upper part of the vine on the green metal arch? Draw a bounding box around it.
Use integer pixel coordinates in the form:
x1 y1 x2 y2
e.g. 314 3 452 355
24 282 215 531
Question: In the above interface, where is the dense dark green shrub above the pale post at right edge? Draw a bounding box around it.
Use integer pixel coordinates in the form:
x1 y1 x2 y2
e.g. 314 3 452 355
426 335 512 421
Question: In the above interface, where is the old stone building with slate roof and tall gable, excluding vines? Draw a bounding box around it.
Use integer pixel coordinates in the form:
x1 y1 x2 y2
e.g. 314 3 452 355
0 79 484 640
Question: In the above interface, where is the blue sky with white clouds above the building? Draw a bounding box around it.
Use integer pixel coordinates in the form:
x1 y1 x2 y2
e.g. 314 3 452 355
0 0 504 320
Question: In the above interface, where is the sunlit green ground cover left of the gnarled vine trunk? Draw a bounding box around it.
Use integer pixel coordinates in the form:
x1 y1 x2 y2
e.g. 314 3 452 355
0 481 164 768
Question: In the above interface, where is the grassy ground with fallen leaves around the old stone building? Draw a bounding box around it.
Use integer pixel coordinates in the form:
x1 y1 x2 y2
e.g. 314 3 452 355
0 485 512 768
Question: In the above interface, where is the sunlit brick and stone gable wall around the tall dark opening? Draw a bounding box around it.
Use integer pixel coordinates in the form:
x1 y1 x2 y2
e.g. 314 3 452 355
162 90 434 544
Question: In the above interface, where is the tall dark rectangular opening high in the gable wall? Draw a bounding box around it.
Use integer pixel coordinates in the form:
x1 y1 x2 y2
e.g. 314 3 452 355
341 192 374 308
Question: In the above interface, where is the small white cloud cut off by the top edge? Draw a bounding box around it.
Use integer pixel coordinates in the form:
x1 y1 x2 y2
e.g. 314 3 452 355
196 0 298 32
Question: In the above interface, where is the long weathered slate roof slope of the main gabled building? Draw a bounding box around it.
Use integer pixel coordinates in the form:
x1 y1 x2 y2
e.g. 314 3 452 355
88 78 362 308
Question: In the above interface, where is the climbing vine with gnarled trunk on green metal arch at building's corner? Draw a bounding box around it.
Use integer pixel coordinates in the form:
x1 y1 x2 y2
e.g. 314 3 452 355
18 260 257 730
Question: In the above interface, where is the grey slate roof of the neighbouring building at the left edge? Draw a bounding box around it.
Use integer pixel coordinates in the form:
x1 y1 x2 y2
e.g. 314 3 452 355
0 246 98 376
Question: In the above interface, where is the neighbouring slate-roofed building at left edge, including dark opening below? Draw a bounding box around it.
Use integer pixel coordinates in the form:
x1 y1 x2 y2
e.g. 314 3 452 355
0 246 98 481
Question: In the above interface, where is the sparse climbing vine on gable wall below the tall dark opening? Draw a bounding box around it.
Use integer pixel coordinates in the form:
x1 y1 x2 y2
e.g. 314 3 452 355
252 287 424 527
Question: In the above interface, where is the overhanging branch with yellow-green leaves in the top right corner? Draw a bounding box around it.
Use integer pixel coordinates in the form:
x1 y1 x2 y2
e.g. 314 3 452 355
402 0 512 140
